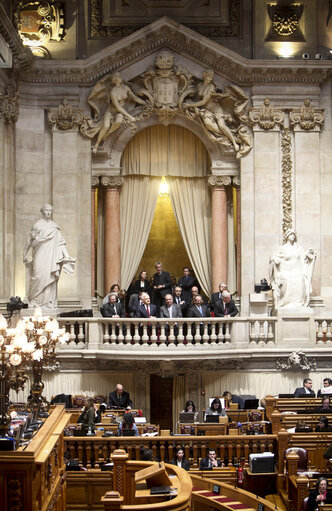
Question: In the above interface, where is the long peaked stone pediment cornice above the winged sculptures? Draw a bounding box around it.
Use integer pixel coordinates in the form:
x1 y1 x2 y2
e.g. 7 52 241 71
13 17 332 86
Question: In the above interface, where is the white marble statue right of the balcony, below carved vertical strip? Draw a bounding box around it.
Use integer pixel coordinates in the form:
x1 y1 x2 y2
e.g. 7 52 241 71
269 229 317 309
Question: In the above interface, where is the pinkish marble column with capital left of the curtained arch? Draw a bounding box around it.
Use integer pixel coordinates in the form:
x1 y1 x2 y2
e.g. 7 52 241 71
101 176 123 294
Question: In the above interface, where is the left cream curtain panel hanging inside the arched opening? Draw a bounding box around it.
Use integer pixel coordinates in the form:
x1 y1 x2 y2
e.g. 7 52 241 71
120 176 160 289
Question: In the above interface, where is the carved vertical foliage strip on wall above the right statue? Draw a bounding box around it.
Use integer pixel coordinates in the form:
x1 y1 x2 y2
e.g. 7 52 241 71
281 128 293 234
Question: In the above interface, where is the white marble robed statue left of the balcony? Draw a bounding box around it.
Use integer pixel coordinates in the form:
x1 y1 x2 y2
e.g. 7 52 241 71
23 204 76 308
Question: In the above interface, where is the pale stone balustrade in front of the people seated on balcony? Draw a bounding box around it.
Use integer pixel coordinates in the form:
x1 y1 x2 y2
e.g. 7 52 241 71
59 316 277 352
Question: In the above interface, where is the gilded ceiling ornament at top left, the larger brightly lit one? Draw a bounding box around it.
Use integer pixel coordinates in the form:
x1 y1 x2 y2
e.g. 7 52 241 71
14 0 64 57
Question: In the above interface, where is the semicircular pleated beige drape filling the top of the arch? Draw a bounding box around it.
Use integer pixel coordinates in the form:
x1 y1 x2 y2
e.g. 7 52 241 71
122 125 210 177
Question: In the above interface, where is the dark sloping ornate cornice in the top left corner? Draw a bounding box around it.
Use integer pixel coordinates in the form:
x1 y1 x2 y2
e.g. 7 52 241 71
0 3 33 69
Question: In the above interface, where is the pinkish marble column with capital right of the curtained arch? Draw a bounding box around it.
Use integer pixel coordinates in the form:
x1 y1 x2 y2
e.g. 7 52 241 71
209 176 232 292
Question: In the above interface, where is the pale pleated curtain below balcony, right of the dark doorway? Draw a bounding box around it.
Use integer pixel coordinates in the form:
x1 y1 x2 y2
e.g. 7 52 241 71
202 371 324 406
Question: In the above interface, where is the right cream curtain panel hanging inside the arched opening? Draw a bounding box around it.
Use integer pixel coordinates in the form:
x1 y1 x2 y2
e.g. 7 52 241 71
169 178 211 296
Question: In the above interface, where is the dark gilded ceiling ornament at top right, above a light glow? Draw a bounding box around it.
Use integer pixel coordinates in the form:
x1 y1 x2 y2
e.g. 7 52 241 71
267 1 304 37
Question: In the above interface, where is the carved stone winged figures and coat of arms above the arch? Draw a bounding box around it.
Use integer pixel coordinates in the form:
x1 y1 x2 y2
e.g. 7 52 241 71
80 51 252 158
